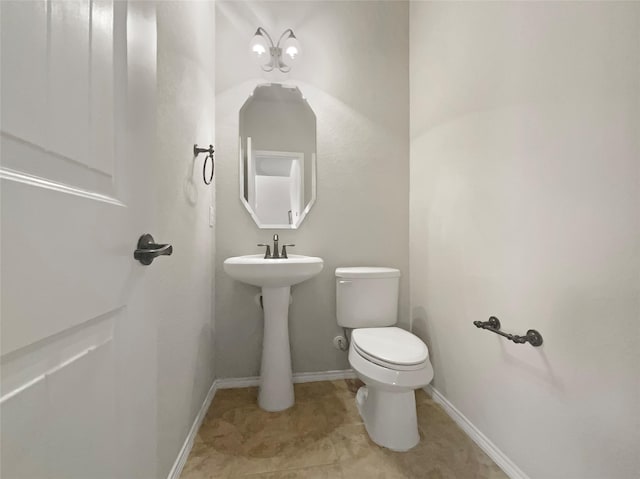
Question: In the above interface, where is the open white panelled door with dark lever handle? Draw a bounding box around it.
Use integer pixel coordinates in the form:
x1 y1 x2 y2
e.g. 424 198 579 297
0 0 160 479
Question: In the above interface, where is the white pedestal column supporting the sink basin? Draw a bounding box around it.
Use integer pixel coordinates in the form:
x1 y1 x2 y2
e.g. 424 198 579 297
258 286 294 411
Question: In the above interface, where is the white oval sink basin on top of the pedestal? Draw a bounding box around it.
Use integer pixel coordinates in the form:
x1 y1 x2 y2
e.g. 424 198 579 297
224 254 324 288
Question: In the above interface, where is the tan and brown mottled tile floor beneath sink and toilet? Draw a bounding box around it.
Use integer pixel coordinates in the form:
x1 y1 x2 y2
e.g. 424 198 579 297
181 380 507 479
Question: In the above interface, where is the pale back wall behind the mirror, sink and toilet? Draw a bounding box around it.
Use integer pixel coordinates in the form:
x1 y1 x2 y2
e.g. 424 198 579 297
216 1 409 377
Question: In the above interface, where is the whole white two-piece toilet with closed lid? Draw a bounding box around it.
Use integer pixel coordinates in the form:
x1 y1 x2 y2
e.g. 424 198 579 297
336 267 433 451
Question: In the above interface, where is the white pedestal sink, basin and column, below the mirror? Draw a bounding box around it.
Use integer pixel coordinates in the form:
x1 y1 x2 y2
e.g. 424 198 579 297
224 254 324 411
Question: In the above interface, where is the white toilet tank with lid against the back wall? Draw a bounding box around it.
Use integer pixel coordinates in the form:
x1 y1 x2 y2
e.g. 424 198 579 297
336 267 400 328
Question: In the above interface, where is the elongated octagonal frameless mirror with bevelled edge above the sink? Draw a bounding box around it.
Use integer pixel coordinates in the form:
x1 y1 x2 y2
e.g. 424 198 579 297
239 83 316 229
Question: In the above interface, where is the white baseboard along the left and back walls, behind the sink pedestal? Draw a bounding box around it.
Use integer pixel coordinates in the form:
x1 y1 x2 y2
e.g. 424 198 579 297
167 369 356 479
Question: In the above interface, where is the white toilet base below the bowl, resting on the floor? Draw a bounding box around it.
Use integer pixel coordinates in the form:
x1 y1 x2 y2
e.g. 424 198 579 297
356 386 420 452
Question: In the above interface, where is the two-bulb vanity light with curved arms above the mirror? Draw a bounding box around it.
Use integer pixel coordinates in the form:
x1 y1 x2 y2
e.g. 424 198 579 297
251 27 300 73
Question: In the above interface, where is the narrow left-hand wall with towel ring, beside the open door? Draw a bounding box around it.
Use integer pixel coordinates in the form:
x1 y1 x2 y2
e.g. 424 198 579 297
156 1 216 477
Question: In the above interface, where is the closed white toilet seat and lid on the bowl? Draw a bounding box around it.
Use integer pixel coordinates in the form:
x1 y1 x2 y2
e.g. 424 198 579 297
351 327 429 371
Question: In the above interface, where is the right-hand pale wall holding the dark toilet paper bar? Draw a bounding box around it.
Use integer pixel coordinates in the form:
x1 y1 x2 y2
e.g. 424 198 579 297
410 2 640 479
